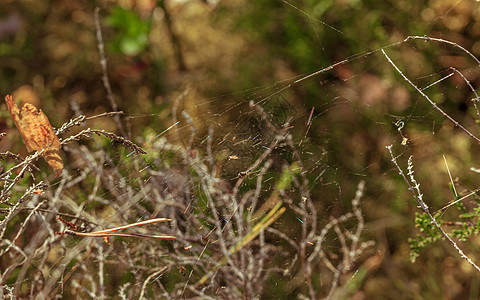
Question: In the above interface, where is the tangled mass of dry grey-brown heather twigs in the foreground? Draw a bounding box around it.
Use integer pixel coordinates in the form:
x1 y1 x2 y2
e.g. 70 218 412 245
0 95 372 299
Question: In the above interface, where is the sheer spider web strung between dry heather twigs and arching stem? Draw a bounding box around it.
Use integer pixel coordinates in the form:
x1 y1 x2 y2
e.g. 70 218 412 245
90 41 476 293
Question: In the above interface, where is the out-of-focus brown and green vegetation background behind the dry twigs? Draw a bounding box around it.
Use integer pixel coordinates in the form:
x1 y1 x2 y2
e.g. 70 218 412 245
0 0 480 299
